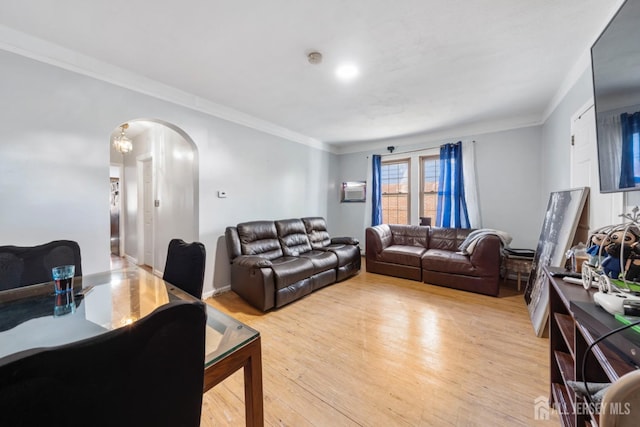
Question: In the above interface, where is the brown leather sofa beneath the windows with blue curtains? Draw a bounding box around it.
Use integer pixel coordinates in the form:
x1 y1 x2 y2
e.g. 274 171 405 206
366 224 502 296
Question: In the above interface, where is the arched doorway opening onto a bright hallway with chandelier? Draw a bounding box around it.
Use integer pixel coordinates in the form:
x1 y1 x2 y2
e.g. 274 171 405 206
110 119 199 274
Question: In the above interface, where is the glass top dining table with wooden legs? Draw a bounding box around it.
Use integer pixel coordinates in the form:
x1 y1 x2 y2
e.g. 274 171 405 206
0 267 262 425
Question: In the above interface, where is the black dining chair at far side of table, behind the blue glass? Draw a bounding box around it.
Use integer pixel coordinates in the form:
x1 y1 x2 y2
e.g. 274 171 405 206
0 240 82 291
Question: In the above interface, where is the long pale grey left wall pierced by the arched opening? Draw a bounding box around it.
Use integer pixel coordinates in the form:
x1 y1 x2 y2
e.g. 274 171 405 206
0 51 332 293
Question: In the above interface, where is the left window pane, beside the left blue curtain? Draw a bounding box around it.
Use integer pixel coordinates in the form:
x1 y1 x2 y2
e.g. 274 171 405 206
381 159 409 224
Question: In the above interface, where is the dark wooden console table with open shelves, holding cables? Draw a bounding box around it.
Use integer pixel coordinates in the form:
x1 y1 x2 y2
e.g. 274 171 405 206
544 269 640 426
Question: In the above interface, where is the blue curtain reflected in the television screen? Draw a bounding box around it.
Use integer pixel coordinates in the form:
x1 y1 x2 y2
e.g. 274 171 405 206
619 111 640 188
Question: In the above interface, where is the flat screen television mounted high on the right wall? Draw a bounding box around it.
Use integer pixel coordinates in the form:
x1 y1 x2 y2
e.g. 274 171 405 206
591 0 640 193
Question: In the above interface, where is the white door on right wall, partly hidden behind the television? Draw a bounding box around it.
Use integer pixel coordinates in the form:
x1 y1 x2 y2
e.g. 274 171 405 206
570 102 623 231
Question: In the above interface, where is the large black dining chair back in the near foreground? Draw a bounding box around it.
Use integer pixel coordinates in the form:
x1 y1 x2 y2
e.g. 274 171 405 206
0 301 206 427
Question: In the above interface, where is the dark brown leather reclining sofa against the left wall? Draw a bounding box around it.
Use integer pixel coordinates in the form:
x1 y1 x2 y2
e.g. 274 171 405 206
225 217 361 311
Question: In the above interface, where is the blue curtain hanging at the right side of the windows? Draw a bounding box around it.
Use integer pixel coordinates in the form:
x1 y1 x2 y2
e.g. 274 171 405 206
436 141 470 228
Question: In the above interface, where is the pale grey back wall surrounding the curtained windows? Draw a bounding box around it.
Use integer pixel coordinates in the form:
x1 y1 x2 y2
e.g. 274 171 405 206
329 126 546 249
